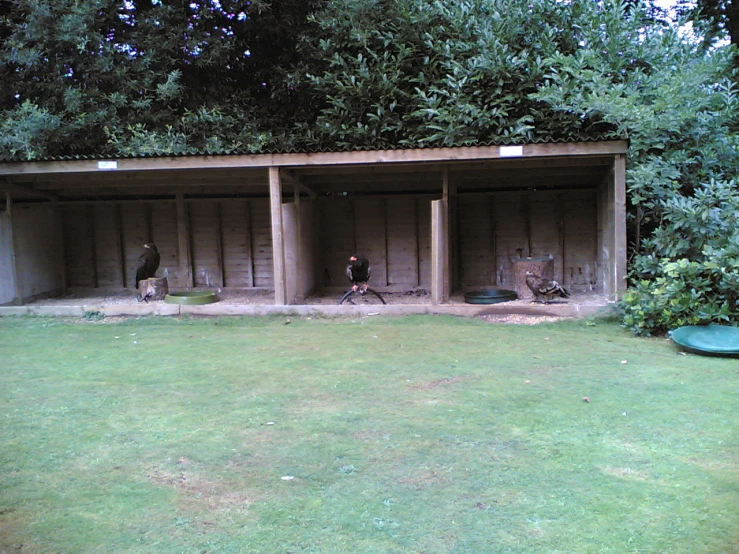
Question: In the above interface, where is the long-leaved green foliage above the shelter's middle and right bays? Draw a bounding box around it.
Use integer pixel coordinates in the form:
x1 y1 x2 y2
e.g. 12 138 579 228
292 0 613 148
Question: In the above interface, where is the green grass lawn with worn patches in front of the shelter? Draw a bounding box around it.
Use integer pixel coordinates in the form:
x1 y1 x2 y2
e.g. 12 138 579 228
0 316 739 554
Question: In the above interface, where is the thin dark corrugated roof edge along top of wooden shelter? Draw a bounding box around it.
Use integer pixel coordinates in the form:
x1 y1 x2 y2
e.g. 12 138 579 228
0 133 627 163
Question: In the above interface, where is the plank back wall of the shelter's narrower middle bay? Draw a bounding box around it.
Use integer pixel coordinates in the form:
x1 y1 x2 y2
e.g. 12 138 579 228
317 196 431 289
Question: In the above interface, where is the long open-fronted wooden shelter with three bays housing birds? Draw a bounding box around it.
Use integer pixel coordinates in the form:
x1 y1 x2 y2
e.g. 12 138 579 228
0 141 628 305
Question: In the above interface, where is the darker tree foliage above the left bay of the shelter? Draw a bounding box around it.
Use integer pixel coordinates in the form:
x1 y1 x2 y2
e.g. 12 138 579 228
0 0 314 158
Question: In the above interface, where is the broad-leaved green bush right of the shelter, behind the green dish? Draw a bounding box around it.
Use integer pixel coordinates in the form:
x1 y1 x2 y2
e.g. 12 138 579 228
621 181 739 335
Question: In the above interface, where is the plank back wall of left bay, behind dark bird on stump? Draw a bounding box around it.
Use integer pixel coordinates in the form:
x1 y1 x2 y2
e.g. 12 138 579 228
62 199 274 288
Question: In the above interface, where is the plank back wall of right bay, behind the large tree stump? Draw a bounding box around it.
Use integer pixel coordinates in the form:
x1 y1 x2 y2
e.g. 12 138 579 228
458 189 602 291
